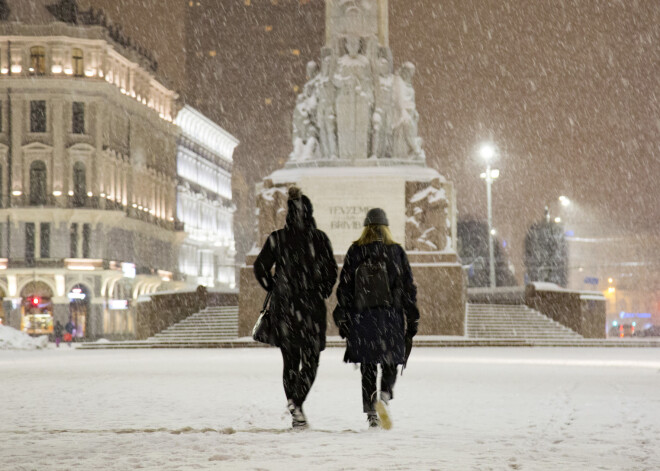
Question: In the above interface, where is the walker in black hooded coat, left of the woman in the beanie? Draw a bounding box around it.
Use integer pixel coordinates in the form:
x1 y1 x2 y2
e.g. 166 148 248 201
254 187 337 427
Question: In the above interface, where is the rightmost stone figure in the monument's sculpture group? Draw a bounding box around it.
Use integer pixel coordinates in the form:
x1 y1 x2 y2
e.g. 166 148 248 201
392 62 425 160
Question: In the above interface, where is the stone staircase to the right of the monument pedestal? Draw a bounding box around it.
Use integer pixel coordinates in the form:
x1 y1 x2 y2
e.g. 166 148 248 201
466 303 583 341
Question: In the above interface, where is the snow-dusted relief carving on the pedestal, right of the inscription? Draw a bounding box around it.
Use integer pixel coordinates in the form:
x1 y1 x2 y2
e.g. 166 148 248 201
406 178 452 252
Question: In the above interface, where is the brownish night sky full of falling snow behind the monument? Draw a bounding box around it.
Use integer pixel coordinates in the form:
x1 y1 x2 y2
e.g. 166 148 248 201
89 0 660 276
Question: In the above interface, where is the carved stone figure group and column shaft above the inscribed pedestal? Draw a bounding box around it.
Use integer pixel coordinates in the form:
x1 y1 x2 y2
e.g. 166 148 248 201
289 0 426 166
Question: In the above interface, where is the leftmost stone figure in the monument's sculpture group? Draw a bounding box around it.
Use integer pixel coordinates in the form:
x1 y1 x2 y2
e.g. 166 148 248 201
289 61 321 161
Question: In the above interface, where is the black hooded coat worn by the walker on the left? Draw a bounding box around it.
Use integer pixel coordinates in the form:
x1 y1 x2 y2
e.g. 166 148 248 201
254 196 337 351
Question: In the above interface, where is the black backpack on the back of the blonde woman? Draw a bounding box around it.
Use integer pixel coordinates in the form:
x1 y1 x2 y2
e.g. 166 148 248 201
355 246 393 312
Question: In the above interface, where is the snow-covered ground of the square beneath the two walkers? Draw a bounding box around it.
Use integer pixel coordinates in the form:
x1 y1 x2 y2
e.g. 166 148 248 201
0 346 660 471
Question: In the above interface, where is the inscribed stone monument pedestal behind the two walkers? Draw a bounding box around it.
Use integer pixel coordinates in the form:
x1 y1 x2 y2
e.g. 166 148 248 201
239 165 467 336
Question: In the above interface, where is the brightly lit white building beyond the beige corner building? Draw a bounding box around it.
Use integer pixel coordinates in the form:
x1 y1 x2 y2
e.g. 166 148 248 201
175 106 238 290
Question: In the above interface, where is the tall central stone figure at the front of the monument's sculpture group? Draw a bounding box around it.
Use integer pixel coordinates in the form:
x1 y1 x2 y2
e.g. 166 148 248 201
333 36 374 160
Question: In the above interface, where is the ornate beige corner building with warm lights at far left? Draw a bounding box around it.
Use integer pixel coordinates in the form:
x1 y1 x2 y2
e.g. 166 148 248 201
0 0 185 337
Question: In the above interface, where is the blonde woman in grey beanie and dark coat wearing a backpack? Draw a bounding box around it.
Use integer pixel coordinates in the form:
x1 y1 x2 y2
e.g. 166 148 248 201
333 208 419 428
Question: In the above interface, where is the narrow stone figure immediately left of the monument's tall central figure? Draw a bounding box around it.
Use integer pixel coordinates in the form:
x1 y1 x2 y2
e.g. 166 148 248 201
318 48 338 159
